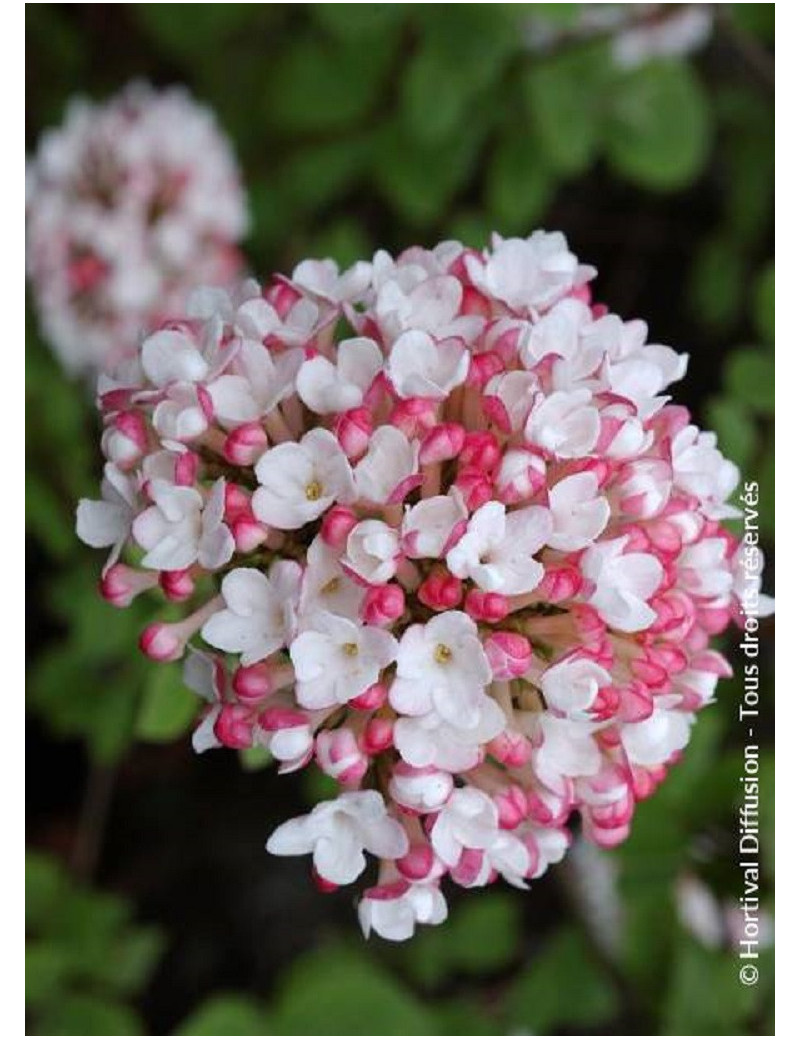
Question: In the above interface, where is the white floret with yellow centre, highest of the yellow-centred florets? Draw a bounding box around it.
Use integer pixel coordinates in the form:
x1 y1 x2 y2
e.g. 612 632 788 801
252 430 354 530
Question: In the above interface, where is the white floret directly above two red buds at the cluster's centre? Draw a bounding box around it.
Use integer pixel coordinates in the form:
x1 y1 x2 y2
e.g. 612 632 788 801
447 502 551 596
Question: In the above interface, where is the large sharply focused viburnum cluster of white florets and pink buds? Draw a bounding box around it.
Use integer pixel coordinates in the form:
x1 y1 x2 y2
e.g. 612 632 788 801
78 232 769 940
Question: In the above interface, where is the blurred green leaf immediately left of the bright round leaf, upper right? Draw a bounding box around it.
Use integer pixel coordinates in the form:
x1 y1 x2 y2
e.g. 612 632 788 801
520 47 609 176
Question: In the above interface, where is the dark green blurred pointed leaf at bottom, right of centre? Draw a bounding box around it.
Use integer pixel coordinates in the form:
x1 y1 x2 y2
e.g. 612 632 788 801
507 929 618 1035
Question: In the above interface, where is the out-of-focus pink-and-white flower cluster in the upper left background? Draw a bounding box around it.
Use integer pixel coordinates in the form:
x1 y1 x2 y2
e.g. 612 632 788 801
27 83 247 372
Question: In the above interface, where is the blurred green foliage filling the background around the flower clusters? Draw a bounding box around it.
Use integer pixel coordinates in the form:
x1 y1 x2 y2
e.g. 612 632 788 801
26 3 775 1036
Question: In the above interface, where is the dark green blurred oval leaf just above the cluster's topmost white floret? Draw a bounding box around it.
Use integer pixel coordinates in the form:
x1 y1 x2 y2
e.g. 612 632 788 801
487 128 554 233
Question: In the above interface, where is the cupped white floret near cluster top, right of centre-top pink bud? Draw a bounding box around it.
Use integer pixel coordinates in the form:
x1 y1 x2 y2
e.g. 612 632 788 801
387 329 469 400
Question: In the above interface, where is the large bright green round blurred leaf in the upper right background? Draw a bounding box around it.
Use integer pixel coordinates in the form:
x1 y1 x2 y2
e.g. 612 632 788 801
605 61 712 191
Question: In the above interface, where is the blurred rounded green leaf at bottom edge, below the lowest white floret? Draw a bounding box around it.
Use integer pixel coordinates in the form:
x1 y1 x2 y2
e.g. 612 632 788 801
273 946 436 1036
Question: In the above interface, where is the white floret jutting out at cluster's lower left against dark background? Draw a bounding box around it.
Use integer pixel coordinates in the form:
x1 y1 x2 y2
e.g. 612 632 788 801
266 790 409 885
